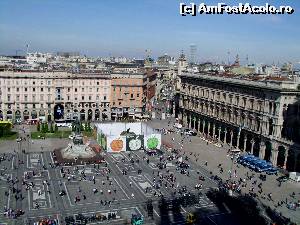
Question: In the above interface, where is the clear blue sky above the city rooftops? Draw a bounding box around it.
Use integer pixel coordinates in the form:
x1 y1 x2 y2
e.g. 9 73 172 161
0 0 300 64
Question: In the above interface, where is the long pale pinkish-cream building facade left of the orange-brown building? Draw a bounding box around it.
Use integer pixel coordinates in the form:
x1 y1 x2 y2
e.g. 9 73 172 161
0 71 111 121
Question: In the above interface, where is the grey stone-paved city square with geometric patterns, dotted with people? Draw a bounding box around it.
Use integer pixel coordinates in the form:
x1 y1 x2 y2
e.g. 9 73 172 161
0 115 300 225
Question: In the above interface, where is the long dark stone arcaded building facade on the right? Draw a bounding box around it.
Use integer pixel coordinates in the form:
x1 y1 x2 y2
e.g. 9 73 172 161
178 73 300 171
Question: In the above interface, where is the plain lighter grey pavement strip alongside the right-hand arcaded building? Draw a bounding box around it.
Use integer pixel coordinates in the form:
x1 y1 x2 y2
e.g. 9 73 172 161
151 118 300 224
